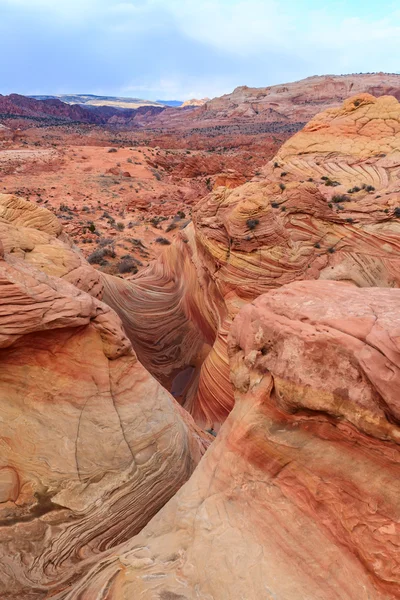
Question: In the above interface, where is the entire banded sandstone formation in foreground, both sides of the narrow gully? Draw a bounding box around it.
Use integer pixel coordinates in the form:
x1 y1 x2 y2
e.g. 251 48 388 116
0 94 400 600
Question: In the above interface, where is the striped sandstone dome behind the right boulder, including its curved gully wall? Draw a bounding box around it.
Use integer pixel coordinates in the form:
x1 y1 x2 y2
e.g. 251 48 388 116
97 94 400 429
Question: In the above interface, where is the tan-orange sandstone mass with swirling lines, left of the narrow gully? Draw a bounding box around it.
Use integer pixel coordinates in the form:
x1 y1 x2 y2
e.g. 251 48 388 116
0 196 209 600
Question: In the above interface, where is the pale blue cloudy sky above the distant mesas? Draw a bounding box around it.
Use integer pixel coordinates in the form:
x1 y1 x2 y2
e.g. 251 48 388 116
0 0 400 100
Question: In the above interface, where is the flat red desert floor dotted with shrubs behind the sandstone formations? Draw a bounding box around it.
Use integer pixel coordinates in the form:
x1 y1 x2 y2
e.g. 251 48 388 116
0 127 281 276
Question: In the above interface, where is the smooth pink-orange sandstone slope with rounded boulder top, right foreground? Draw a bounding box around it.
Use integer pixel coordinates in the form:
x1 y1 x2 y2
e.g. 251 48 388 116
51 281 400 600
